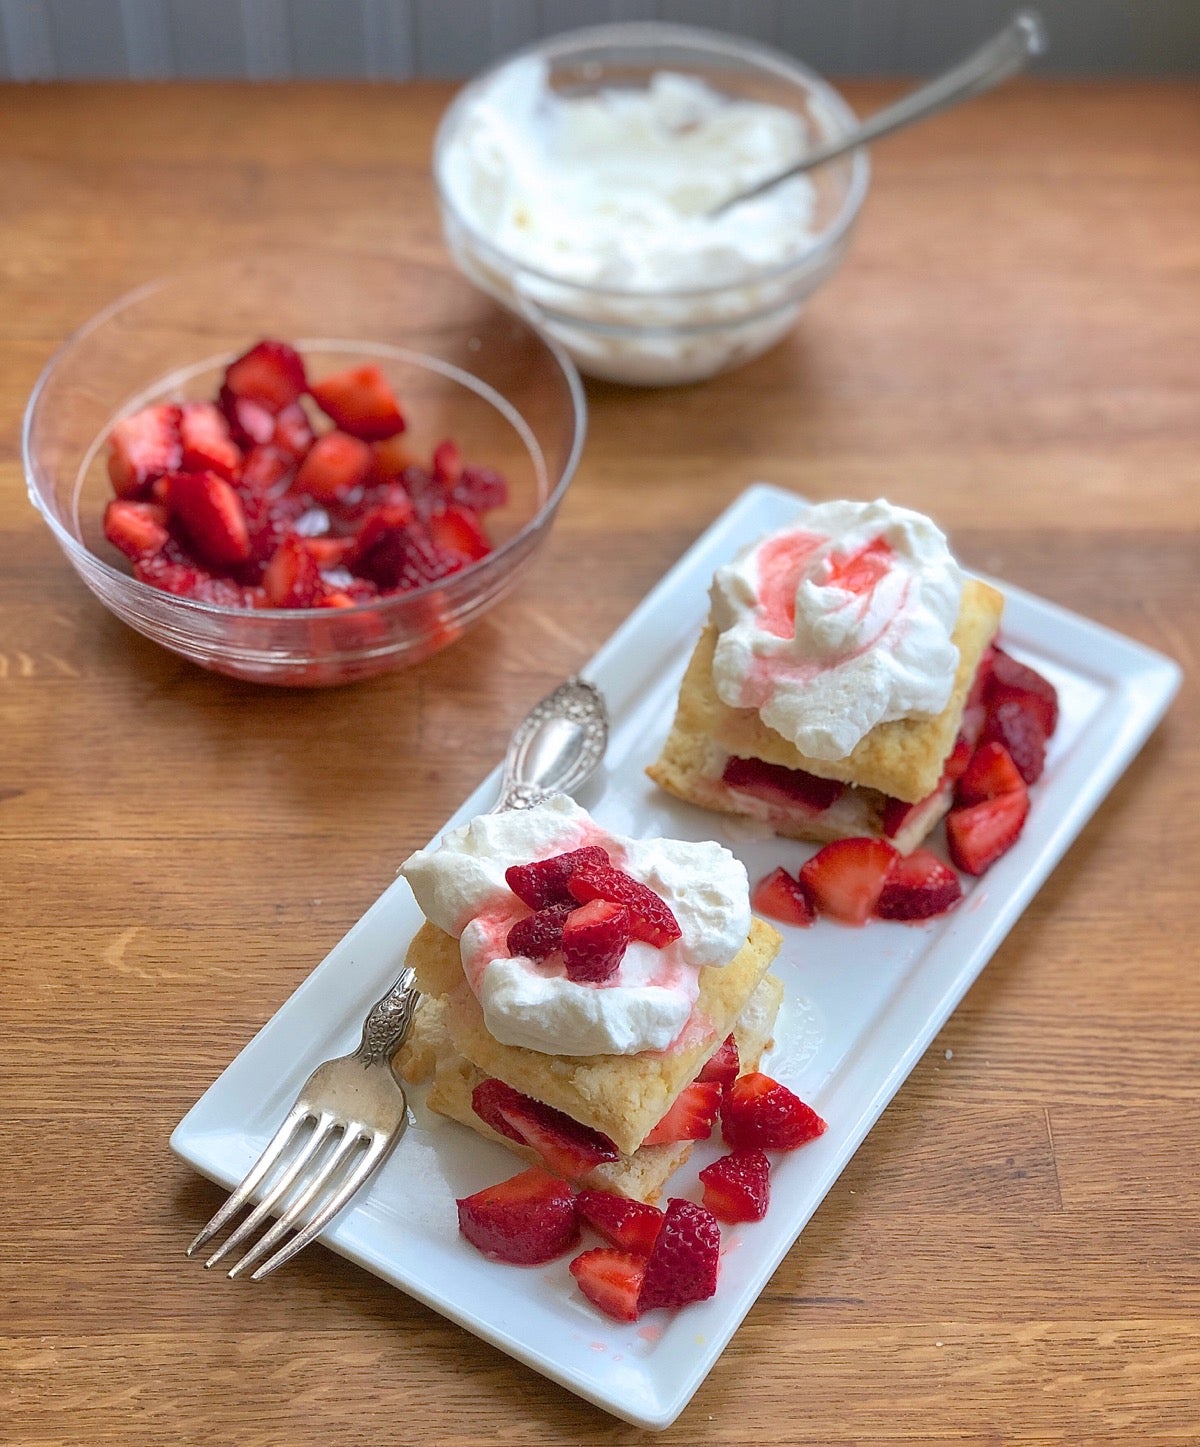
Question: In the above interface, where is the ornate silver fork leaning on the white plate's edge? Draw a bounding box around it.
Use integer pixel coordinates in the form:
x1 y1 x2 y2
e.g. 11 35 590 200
187 679 608 1281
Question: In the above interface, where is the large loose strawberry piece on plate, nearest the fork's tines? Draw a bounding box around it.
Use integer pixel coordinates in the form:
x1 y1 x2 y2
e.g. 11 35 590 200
457 1166 579 1266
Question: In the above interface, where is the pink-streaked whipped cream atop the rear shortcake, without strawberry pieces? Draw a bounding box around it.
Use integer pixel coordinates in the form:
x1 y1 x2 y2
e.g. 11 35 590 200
712 499 963 760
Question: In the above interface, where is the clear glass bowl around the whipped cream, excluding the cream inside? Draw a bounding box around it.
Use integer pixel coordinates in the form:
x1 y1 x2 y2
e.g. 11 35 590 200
434 23 870 386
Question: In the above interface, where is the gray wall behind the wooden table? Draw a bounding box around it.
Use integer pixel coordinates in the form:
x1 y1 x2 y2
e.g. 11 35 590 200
0 0 1200 81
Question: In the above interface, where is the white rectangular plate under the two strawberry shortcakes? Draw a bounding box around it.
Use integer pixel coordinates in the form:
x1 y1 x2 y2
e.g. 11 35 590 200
171 485 1180 1428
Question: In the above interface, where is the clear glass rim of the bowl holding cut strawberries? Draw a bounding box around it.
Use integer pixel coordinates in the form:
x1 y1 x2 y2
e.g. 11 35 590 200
20 246 588 622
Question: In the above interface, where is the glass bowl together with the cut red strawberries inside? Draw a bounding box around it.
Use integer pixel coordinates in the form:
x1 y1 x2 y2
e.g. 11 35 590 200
23 250 586 686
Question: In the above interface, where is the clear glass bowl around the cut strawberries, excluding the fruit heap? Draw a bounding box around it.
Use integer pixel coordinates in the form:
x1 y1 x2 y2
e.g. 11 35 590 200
23 250 586 686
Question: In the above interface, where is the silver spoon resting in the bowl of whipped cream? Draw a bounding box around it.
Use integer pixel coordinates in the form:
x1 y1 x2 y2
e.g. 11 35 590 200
708 10 1047 216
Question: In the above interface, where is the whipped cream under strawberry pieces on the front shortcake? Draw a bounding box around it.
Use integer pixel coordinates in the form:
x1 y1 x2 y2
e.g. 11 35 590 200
401 794 750 1055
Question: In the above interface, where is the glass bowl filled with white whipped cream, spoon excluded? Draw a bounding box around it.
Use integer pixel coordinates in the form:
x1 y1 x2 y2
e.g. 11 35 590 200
434 23 870 386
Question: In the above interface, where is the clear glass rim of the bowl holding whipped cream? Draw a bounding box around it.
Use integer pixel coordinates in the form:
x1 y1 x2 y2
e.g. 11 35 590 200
431 20 870 300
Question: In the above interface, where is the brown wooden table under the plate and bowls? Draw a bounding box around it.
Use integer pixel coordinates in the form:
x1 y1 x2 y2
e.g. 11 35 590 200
0 84 1200 1447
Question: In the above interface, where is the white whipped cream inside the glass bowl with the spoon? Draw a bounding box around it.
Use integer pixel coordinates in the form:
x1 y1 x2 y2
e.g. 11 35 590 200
439 56 815 292
